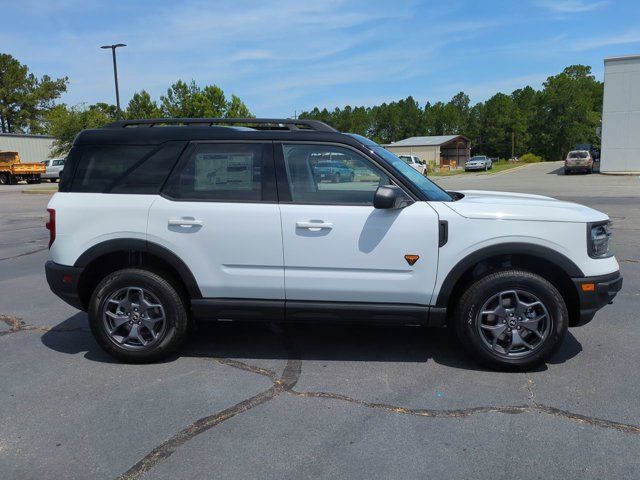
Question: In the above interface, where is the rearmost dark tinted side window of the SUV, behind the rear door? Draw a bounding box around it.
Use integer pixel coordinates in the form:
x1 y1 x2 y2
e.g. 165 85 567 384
71 145 154 193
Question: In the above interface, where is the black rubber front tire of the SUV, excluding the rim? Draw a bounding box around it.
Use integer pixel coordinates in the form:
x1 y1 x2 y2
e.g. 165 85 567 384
456 271 568 369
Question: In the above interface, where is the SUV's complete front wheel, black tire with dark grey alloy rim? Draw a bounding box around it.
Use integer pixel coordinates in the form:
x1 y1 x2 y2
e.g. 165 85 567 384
453 270 569 371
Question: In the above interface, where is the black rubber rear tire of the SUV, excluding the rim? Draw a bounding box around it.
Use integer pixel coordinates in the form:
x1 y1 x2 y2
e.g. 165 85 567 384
88 269 188 363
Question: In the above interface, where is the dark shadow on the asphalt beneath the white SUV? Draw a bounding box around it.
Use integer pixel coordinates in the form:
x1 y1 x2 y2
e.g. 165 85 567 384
41 313 582 371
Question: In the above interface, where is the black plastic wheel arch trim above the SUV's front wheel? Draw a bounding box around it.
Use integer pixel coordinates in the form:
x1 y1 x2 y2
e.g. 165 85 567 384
435 243 584 325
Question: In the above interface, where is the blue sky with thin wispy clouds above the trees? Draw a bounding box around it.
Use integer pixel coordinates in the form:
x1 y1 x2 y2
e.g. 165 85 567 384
0 0 640 117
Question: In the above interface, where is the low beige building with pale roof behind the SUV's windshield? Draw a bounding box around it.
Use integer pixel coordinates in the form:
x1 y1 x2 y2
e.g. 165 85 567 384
384 135 470 166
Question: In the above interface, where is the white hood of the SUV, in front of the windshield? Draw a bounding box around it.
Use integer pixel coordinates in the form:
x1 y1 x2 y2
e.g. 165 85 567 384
447 190 609 223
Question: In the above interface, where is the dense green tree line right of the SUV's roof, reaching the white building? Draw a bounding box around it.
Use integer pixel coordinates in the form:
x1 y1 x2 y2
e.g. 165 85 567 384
300 65 603 160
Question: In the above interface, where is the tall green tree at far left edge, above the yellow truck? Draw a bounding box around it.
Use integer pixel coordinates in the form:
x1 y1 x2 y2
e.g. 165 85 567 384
0 53 68 133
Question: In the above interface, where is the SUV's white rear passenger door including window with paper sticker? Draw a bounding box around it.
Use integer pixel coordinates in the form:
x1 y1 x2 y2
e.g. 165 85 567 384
147 142 284 301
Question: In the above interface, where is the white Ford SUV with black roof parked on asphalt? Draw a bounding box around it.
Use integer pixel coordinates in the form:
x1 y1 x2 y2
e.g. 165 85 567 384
46 119 622 369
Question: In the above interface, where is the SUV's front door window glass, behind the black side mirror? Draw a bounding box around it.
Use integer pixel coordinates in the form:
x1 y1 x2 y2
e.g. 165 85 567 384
283 144 390 205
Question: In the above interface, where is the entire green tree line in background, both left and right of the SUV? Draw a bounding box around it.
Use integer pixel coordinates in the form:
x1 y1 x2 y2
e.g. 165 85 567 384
0 54 603 160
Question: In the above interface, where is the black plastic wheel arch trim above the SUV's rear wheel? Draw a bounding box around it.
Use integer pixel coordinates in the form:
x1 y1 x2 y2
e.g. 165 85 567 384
74 239 202 307
